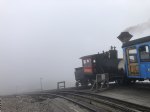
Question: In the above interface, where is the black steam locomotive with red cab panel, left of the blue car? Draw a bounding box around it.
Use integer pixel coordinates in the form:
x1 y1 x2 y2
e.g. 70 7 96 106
75 47 125 87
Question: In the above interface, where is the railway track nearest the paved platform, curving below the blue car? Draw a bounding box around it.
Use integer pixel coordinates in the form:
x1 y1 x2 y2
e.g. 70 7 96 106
54 91 150 112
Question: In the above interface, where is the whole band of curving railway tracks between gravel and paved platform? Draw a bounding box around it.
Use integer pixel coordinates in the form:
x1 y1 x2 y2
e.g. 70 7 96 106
28 90 150 112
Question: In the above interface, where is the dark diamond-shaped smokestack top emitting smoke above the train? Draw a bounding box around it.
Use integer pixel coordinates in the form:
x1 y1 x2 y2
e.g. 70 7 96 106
117 32 133 43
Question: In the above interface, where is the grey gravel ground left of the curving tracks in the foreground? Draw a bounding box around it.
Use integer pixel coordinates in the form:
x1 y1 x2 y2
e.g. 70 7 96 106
2 96 88 112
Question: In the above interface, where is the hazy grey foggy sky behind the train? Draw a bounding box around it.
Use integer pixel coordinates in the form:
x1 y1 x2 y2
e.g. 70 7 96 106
0 0 150 94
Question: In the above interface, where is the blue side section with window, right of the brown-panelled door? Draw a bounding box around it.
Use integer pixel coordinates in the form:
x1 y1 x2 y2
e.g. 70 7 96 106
139 45 150 79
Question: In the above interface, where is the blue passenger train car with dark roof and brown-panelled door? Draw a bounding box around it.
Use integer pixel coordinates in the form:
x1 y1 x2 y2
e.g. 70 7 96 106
122 36 150 81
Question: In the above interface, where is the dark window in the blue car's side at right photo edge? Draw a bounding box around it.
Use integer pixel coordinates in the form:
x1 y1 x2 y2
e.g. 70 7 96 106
139 45 150 61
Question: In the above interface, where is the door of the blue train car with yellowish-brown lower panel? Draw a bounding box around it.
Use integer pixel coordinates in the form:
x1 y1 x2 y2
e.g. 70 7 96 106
126 46 139 77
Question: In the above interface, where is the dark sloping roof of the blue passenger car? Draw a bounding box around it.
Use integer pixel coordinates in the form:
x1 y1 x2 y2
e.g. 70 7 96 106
122 36 150 47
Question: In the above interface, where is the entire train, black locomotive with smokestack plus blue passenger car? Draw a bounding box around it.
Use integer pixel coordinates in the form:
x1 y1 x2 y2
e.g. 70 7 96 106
75 32 150 87
